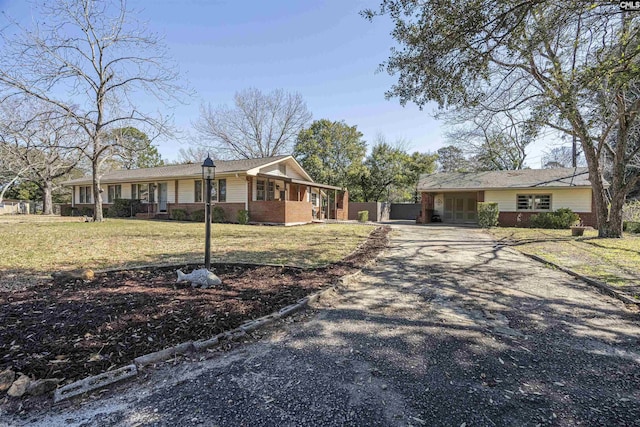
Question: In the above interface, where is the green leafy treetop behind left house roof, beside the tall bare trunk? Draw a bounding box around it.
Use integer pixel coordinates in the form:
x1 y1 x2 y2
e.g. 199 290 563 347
106 126 164 169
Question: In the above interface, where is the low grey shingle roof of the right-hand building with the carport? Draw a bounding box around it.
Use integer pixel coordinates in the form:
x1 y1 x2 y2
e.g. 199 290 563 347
418 168 591 191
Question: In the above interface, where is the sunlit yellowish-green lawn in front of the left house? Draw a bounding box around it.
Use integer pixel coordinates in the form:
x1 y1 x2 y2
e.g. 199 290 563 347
0 217 372 284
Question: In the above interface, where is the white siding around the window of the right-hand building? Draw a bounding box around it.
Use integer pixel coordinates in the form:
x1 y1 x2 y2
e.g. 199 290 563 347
484 188 591 212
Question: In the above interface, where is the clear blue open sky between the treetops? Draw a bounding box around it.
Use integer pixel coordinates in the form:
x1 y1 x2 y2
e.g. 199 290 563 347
0 0 552 167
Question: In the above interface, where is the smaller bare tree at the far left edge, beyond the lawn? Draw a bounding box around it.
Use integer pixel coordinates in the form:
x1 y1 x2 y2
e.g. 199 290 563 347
0 98 82 215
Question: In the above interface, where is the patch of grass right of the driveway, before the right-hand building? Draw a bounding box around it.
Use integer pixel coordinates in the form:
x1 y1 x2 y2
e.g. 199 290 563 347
490 228 640 295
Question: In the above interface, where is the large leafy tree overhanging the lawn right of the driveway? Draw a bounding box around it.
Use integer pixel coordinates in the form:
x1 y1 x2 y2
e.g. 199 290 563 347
364 0 640 237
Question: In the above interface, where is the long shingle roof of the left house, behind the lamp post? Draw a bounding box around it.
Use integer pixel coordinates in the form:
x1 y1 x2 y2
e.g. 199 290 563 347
64 155 289 185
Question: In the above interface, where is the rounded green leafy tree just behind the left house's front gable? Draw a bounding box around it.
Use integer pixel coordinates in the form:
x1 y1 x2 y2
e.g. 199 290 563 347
293 119 367 187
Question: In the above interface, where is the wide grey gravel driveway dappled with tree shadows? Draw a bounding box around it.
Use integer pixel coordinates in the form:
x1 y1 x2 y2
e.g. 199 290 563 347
5 225 640 427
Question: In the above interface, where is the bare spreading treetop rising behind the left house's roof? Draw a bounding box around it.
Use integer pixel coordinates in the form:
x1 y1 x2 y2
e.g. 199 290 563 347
194 88 311 159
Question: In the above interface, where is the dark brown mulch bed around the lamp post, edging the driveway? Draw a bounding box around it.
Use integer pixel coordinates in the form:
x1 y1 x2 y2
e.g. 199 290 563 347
0 227 389 392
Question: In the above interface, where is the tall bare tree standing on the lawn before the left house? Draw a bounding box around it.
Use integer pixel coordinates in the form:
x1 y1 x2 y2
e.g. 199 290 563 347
0 0 185 221
